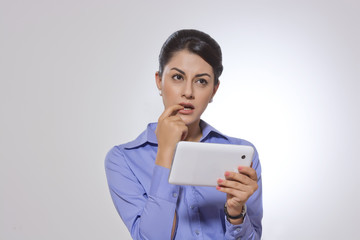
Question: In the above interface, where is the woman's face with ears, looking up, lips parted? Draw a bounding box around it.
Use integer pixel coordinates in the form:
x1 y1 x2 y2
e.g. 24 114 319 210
156 50 219 126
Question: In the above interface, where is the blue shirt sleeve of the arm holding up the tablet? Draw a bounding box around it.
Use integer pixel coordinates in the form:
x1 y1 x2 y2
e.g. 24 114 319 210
225 147 263 240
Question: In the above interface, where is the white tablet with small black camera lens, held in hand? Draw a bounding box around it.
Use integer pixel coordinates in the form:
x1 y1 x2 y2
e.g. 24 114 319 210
169 141 254 186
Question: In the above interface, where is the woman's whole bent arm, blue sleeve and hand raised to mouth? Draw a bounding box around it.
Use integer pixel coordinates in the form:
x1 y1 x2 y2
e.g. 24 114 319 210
105 105 187 240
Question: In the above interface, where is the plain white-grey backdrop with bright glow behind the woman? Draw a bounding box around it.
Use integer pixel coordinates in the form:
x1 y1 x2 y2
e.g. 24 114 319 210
0 0 360 240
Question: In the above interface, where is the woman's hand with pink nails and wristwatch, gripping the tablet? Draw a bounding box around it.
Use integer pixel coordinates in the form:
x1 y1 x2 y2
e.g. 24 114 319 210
216 167 258 225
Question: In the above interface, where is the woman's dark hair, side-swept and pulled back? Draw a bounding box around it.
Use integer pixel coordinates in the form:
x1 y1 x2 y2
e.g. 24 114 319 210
159 29 223 86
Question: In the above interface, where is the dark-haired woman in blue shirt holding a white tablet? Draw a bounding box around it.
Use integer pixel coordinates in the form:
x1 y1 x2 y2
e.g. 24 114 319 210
105 30 262 240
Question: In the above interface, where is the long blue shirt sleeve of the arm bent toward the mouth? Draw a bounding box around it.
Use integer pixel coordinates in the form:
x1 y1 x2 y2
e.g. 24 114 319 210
105 147 179 240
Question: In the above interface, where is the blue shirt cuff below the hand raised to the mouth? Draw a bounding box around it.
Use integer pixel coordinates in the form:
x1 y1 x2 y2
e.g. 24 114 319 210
149 165 180 203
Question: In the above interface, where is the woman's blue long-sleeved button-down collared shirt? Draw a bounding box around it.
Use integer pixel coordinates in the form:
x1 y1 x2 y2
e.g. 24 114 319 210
105 121 263 240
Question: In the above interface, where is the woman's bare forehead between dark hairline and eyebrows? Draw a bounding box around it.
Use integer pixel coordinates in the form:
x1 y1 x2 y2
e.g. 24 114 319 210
164 50 213 76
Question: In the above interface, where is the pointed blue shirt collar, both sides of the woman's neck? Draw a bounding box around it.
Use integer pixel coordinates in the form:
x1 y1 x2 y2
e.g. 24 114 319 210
124 120 229 149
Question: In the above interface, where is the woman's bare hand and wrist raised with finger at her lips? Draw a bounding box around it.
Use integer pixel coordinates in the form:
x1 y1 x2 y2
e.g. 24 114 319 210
155 105 188 168
